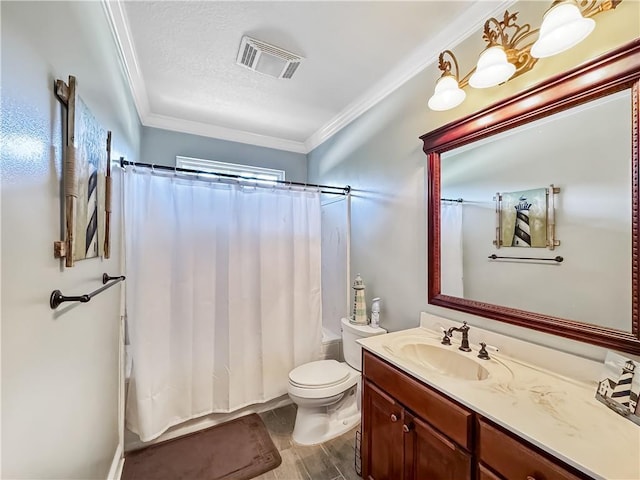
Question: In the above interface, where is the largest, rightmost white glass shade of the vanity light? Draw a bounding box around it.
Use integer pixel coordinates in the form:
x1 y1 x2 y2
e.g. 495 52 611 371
531 1 596 58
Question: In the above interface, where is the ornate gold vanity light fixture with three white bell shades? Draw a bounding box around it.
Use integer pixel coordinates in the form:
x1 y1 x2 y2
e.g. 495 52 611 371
428 0 622 111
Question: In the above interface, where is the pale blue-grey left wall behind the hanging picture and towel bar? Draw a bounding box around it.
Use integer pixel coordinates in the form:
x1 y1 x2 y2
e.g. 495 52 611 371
0 1 140 479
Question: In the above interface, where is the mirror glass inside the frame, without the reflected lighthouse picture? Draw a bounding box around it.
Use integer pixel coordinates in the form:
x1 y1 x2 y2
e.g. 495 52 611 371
440 89 632 332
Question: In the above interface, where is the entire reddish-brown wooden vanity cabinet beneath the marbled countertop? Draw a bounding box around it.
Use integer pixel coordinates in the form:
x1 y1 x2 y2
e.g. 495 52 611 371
361 350 591 480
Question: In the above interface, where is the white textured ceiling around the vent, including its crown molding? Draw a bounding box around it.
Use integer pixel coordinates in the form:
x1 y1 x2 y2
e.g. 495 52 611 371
105 0 512 153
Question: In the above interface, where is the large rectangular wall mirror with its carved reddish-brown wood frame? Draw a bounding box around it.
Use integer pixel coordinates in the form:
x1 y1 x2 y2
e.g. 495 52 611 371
421 40 640 354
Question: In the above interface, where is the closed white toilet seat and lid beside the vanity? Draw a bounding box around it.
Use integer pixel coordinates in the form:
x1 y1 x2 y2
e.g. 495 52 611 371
288 360 360 399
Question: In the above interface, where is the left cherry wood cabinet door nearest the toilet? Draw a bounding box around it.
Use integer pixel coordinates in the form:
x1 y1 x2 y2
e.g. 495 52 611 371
362 380 404 480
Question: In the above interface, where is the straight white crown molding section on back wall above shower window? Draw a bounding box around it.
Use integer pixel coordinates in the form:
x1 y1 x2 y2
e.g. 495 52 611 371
143 113 308 154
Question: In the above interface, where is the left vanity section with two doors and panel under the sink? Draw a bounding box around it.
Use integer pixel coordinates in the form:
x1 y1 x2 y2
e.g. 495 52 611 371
362 352 473 480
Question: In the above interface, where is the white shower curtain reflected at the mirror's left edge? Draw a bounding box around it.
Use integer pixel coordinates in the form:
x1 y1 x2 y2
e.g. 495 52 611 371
440 201 464 297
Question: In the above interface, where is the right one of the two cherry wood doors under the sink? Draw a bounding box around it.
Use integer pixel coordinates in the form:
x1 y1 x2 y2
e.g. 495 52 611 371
404 414 471 480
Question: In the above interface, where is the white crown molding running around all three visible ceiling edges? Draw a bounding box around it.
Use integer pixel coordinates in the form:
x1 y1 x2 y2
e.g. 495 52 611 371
102 0 516 154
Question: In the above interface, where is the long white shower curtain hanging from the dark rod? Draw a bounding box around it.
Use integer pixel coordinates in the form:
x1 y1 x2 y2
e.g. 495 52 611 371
124 168 322 441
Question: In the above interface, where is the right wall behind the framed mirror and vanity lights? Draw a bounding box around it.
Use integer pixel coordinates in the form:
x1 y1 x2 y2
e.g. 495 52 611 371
309 1 640 358
